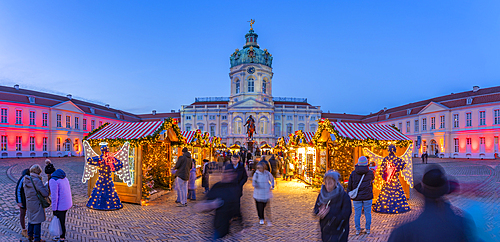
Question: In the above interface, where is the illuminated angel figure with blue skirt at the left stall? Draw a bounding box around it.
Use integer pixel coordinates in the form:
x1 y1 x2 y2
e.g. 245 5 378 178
82 140 132 210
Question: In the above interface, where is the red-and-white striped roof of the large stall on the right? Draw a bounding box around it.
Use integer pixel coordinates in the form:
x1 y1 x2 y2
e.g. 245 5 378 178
332 122 410 140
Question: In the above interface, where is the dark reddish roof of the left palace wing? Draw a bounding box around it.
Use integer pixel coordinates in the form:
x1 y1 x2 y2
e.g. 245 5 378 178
0 86 140 122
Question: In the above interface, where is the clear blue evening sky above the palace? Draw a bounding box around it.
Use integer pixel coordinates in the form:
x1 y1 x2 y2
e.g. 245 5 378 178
0 1 500 114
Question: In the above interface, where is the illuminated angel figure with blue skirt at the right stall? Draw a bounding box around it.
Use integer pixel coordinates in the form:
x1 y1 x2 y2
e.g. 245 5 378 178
363 144 413 214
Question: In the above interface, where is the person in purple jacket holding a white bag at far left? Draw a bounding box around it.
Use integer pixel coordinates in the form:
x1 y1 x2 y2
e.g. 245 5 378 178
49 169 73 241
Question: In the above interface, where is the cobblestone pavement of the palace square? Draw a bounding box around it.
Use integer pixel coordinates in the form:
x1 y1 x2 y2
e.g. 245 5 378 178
0 158 500 241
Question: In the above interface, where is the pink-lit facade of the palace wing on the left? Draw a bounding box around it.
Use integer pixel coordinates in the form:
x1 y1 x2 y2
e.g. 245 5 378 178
0 101 123 158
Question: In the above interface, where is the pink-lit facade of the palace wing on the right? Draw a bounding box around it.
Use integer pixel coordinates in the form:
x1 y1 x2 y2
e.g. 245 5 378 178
379 102 500 159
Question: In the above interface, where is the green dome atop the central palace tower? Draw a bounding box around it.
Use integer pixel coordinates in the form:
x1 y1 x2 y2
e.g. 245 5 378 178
229 29 273 67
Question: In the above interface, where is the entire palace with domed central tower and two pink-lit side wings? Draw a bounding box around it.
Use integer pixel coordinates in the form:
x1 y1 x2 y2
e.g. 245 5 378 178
0 25 500 159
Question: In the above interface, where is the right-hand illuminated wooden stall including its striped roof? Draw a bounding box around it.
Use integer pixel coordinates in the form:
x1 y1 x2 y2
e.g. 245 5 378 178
313 119 413 199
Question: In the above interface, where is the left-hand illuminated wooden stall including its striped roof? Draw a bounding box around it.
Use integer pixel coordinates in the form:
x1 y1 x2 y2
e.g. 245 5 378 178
84 119 183 205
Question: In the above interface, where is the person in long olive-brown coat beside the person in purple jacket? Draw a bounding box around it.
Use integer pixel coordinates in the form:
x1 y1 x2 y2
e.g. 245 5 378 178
23 164 50 242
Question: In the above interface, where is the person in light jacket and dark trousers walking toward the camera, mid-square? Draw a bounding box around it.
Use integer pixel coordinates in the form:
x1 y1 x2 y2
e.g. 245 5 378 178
252 162 274 226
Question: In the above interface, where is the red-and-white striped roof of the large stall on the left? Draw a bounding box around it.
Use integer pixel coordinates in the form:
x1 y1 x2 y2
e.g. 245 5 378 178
87 121 163 140
